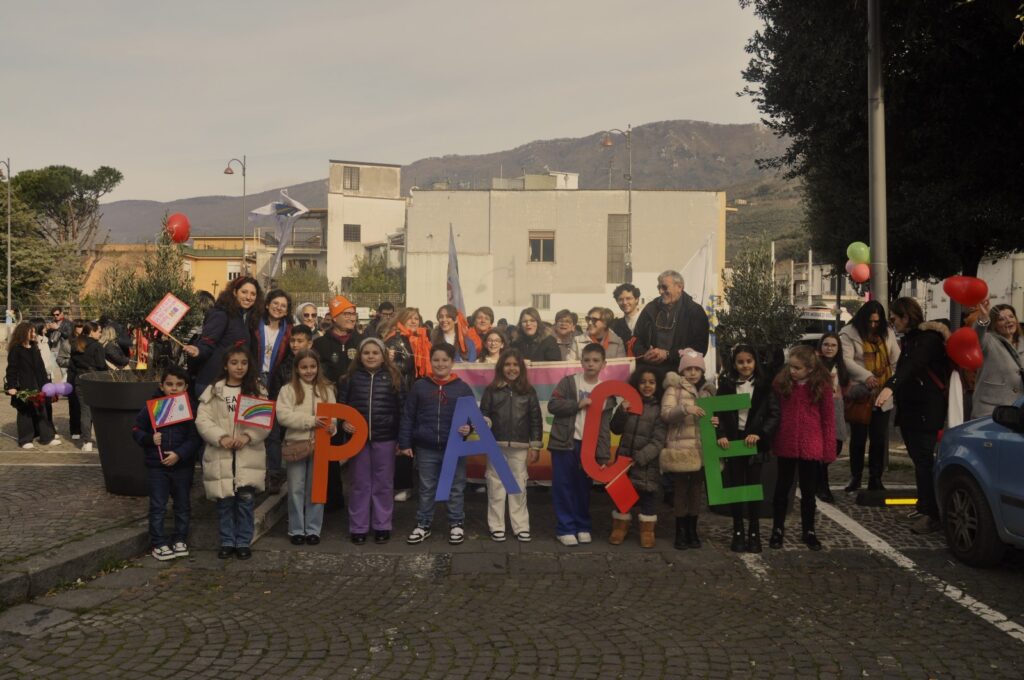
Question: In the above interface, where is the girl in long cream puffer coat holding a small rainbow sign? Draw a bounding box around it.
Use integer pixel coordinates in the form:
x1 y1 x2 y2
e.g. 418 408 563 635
196 347 270 559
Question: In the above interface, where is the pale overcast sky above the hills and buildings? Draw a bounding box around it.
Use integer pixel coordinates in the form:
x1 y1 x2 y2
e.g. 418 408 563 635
0 0 758 201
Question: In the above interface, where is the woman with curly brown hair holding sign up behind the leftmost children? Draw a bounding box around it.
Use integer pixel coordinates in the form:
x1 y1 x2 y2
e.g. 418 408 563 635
184 277 263 397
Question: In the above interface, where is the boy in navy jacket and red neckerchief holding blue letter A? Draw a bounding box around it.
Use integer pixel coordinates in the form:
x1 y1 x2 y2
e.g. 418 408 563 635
398 342 473 545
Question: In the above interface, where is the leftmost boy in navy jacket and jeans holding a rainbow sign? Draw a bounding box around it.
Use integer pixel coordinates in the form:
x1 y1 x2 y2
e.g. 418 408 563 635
131 366 203 561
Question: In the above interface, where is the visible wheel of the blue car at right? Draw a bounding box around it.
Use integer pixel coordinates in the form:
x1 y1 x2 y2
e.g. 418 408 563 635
942 473 1006 566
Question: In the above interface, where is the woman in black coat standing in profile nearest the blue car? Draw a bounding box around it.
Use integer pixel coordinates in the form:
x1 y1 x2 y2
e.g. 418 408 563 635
874 298 950 534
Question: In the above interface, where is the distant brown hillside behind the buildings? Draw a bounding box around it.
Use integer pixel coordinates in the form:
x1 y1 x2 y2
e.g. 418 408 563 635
102 121 802 246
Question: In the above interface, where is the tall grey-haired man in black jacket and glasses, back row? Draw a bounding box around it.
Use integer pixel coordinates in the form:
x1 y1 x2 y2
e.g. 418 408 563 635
633 269 714 380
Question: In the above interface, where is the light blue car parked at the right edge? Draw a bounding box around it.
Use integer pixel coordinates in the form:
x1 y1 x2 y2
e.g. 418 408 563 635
935 398 1024 566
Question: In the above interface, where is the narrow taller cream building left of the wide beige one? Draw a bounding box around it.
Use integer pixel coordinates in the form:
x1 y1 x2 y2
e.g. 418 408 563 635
327 161 406 290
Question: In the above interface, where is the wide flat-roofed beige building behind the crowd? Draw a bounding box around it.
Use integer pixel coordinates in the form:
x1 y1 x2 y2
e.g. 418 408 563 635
406 183 725 323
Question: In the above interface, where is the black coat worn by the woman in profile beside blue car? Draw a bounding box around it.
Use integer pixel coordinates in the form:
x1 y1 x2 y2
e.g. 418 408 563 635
886 322 950 431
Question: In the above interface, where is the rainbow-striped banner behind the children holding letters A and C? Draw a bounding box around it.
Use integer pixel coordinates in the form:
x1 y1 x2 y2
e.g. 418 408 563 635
455 357 636 481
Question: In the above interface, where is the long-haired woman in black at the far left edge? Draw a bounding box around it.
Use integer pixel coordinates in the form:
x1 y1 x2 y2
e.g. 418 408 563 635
4 322 59 449
